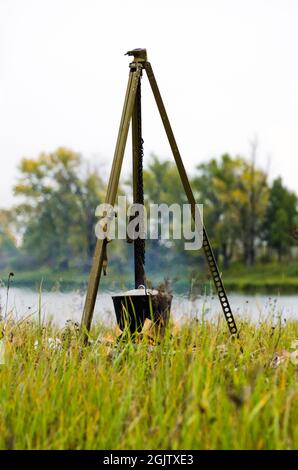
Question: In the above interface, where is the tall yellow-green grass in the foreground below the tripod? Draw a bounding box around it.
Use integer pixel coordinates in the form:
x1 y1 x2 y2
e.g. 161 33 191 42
0 321 298 449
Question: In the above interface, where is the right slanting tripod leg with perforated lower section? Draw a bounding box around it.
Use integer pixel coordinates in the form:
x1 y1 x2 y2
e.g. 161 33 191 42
144 62 237 334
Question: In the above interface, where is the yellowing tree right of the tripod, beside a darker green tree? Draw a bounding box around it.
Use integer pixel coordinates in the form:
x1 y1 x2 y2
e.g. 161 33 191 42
193 154 268 267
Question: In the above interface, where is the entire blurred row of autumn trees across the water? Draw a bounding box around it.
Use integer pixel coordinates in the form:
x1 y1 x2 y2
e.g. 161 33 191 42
0 148 298 271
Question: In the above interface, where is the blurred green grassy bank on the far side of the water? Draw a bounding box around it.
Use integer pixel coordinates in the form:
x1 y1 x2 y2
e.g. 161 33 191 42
1 262 298 295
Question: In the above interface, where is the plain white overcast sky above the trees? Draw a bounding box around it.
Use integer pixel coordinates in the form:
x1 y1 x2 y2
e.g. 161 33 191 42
0 0 298 207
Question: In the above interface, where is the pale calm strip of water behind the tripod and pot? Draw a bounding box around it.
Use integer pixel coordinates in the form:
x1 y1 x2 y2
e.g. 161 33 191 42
0 287 298 326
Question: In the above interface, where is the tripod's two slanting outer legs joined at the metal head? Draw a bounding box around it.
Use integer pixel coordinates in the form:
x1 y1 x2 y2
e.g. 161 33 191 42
81 49 237 338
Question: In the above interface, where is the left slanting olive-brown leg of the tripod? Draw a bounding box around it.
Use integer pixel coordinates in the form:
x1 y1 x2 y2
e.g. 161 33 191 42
81 62 141 341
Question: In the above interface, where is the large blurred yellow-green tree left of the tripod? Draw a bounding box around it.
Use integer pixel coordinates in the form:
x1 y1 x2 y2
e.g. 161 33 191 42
15 148 104 269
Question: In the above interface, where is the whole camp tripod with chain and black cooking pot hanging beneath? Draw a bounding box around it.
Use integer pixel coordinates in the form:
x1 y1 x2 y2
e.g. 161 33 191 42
81 48 237 337
